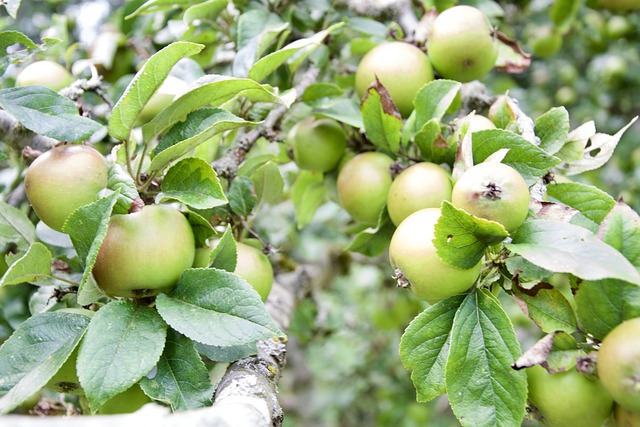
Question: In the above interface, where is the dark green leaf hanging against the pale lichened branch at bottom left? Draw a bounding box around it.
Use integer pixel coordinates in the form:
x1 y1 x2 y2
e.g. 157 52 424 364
140 329 214 412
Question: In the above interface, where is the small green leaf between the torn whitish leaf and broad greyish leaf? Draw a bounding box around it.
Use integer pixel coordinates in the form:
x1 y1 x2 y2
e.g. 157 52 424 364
547 182 616 224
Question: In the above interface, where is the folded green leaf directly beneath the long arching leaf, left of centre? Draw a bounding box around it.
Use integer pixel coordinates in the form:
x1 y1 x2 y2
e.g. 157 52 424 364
149 109 257 175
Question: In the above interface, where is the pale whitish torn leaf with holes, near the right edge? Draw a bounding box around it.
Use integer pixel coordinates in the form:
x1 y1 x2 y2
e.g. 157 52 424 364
557 116 638 176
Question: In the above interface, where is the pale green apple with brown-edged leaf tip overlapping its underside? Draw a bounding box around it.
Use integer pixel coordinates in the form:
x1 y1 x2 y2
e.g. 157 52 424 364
356 42 433 117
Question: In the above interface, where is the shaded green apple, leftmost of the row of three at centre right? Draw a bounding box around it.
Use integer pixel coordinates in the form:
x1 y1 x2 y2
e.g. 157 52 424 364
337 152 393 226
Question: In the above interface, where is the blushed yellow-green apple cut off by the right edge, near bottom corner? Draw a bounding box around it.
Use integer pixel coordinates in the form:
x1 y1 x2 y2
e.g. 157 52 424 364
598 317 640 413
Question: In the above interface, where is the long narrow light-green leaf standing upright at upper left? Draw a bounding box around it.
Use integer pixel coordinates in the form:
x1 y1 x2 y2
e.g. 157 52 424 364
108 42 204 141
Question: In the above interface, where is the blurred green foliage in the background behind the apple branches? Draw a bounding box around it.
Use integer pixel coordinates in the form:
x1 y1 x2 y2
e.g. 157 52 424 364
0 0 640 427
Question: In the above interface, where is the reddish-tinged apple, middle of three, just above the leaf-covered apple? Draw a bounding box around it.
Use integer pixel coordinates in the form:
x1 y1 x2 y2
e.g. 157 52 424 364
387 162 453 226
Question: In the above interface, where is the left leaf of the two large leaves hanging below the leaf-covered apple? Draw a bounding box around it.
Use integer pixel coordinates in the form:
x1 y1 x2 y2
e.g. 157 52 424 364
400 295 466 402
